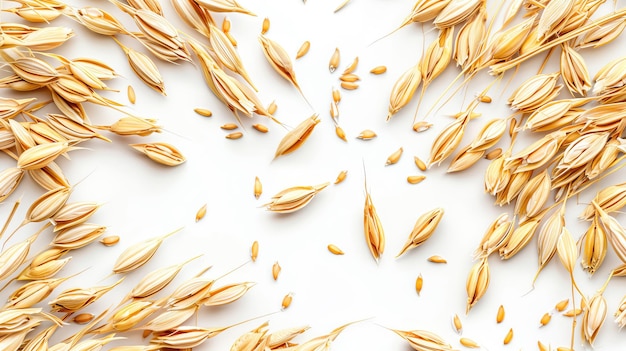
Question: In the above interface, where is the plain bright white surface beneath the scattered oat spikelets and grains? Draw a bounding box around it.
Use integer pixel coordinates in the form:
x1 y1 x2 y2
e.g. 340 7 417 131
0 0 626 350
